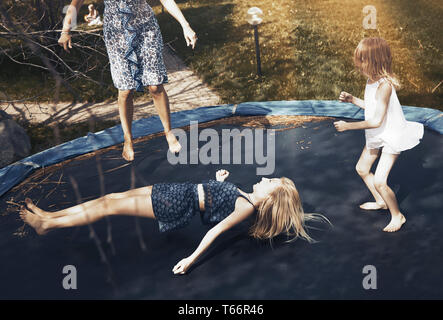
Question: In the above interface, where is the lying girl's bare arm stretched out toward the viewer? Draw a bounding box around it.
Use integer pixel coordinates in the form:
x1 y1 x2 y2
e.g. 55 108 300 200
172 198 254 274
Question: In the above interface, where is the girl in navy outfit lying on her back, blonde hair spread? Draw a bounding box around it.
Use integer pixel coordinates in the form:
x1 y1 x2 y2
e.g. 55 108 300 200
20 170 328 274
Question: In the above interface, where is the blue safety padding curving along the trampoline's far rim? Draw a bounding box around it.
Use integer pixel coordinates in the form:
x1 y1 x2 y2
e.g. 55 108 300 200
0 100 443 196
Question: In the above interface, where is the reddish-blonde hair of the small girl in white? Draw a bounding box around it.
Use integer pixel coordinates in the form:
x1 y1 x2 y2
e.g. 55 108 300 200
354 38 401 89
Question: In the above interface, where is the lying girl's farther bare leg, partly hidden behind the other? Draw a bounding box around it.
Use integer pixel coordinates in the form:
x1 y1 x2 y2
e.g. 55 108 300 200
25 186 152 218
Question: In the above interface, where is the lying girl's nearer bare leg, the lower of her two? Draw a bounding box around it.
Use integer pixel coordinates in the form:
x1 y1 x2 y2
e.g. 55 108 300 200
20 185 155 234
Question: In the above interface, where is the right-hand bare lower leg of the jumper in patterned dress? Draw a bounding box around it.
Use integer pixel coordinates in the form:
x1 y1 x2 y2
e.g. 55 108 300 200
149 85 181 153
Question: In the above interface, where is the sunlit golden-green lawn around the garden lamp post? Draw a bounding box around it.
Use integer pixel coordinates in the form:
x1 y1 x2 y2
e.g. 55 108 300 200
155 0 443 110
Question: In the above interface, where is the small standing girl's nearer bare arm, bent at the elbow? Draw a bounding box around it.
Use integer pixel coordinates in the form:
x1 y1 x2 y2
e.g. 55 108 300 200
334 81 392 132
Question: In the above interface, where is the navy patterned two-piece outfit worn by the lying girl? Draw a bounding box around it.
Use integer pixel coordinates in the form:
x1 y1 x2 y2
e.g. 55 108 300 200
151 180 253 232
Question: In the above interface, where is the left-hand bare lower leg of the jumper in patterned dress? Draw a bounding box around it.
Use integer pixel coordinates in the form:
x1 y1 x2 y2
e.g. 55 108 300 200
118 90 134 161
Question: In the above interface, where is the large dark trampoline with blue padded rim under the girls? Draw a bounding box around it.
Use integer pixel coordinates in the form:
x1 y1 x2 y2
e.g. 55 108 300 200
0 101 443 300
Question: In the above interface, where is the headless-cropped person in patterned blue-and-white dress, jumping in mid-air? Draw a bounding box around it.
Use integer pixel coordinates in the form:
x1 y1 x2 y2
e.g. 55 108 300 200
58 0 197 161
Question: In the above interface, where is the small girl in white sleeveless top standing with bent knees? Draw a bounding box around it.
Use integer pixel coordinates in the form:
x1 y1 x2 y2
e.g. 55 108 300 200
334 38 424 232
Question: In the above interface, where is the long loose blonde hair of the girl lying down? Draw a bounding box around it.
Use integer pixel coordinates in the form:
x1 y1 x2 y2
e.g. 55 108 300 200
249 177 329 242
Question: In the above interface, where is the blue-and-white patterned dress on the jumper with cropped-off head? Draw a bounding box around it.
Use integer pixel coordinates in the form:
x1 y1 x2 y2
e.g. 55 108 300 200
103 0 168 92
